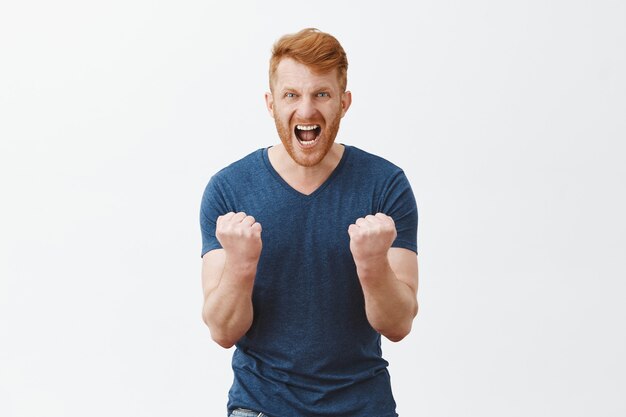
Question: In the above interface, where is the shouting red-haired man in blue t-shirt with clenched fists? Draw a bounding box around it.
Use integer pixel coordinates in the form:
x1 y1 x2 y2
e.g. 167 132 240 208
200 29 418 417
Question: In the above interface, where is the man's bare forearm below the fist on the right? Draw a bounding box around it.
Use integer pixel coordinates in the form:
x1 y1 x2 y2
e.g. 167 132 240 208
357 257 417 342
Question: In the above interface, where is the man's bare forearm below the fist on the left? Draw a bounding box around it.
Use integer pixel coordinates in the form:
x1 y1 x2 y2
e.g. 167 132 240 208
202 257 256 348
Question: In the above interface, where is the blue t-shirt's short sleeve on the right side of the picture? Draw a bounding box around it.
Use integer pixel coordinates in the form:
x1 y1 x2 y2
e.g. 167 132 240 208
380 171 417 253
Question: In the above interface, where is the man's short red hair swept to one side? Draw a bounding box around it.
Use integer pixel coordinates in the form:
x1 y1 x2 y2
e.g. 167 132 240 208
270 28 348 91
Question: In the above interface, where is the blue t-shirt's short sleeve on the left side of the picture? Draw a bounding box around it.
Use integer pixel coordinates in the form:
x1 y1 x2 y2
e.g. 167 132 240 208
200 176 230 256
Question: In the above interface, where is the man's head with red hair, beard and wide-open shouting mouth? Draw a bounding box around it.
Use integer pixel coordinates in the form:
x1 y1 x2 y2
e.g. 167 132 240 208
265 29 352 167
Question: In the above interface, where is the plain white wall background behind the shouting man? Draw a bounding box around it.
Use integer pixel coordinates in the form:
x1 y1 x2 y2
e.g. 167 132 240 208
0 0 626 417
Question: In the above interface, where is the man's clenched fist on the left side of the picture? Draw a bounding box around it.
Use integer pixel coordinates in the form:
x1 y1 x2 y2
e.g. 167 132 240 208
215 211 263 263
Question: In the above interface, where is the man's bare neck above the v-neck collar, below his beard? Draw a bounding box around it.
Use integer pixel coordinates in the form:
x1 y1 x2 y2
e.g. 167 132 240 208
268 143 345 195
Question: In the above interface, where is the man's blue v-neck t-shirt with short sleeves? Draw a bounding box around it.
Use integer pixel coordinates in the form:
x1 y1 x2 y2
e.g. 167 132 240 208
200 146 417 417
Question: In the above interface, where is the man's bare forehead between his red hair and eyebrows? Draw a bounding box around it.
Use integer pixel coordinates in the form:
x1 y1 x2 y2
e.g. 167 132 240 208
272 58 339 89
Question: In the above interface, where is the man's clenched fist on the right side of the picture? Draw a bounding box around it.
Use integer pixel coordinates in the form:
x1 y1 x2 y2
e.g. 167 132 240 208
348 213 397 264
